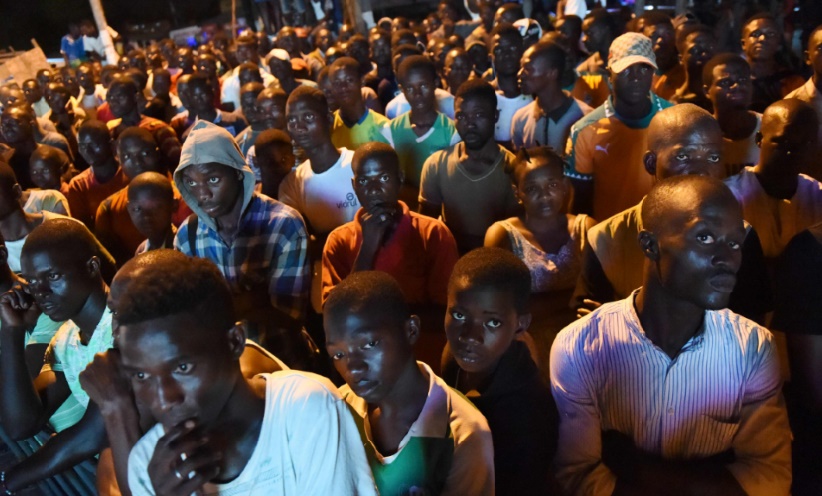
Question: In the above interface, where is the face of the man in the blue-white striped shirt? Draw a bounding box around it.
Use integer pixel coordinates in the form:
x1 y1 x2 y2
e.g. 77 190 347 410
655 198 745 310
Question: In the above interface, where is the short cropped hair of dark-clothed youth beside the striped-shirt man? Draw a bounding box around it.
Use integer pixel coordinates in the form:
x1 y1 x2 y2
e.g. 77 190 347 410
448 247 531 314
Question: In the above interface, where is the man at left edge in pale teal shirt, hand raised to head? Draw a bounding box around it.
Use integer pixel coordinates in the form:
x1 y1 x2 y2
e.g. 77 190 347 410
0 218 113 494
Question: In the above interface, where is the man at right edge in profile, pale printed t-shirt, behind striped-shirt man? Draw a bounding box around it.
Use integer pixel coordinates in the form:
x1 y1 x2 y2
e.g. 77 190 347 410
727 98 822 259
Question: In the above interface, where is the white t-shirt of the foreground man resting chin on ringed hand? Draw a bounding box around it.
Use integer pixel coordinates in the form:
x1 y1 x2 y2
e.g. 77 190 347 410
128 370 377 496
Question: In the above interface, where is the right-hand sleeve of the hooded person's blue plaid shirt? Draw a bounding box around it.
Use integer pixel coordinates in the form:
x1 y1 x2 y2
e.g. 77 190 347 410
268 216 311 322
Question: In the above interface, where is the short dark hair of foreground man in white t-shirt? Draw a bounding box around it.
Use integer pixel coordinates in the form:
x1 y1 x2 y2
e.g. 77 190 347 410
117 252 235 330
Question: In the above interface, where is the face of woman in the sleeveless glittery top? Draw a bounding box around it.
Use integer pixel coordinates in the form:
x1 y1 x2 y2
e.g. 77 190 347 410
517 164 570 219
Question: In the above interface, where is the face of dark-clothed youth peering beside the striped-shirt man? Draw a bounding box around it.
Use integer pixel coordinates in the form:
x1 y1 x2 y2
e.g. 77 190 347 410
445 279 530 374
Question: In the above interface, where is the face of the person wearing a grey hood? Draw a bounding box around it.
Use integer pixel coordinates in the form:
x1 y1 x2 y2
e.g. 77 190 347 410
183 164 243 218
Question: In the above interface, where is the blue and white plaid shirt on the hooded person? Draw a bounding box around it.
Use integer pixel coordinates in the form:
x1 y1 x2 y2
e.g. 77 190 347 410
174 193 311 321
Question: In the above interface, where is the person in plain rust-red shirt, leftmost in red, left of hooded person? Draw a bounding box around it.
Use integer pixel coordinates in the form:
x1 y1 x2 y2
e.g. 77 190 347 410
66 120 128 230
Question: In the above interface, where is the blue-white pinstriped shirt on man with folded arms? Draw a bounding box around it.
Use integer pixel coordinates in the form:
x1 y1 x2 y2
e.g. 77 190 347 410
551 292 791 495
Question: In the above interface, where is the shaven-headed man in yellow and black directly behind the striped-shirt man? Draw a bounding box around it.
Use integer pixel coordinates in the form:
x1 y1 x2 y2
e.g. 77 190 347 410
574 103 772 321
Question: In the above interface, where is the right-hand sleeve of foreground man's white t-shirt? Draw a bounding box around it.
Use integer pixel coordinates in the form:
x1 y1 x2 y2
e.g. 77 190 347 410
286 384 377 496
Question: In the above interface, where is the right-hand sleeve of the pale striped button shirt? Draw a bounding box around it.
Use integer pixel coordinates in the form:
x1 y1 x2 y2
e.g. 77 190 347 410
728 329 791 496
